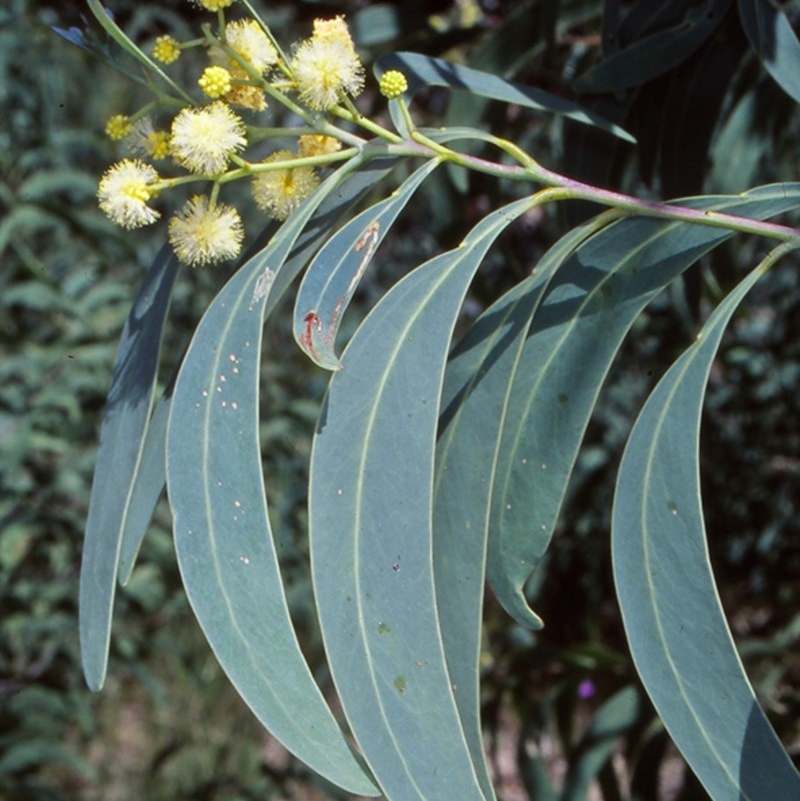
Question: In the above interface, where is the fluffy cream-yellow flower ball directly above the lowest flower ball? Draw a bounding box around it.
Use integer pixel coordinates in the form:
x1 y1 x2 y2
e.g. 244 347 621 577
169 100 247 175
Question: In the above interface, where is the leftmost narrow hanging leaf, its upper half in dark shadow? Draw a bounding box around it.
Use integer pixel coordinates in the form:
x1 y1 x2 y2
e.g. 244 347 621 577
79 248 178 690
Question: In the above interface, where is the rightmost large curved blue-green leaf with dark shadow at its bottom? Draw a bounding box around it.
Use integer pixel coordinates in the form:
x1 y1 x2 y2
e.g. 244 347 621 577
612 247 800 801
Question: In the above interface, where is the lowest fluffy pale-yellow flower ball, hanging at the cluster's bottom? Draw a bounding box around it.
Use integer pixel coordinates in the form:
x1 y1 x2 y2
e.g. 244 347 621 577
169 195 244 266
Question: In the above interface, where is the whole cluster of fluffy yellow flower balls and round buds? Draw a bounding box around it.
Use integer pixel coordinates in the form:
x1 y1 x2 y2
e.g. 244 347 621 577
97 6 406 265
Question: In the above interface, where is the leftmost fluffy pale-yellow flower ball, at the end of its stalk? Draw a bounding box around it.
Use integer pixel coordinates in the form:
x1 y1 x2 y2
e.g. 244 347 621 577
97 159 160 228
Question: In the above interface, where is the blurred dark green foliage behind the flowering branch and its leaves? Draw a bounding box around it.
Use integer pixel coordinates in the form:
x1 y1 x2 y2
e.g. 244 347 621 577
0 0 800 801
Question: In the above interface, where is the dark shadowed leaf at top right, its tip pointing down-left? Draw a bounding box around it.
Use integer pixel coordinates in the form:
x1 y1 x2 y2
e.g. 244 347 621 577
573 0 732 92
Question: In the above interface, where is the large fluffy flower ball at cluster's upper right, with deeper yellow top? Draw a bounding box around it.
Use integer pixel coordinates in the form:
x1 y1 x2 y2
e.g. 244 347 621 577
291 17 364 111
